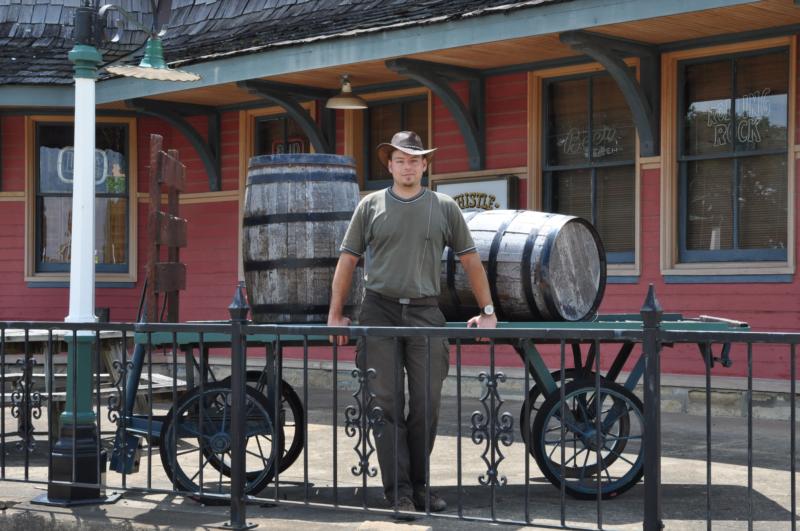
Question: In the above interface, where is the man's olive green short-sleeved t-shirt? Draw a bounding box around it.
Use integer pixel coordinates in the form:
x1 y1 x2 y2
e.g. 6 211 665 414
341 188 475 298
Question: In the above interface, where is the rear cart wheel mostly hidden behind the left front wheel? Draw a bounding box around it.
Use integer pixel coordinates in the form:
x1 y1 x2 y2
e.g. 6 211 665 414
221 371 306 475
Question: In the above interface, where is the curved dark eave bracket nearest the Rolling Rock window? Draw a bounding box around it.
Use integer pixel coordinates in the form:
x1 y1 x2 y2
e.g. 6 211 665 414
559 31 661 157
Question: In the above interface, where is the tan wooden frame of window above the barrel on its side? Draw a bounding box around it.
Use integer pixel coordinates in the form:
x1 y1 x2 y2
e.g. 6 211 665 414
528 58 653 282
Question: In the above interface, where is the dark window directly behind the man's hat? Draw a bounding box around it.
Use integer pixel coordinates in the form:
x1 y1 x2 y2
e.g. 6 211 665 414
364 98 428 190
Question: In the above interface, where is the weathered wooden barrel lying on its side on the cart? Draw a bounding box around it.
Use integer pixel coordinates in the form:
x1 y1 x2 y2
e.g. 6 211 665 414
439 210 606 321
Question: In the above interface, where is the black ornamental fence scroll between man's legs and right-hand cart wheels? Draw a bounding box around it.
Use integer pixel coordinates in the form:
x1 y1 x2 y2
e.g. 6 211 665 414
470 372 514 485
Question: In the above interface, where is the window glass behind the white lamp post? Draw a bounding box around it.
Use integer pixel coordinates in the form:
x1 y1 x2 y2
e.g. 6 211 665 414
32 120 133 275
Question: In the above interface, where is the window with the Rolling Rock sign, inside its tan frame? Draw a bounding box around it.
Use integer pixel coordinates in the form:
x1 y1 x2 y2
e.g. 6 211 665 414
678 49 789 262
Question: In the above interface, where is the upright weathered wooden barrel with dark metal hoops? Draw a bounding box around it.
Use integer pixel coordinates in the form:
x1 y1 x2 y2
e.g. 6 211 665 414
242 153 364 323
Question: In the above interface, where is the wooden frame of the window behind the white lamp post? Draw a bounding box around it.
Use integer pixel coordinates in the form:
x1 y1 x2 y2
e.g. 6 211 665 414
24 115 139 284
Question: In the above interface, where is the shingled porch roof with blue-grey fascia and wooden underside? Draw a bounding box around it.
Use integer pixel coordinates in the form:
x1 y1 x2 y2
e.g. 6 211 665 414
0 0 800 107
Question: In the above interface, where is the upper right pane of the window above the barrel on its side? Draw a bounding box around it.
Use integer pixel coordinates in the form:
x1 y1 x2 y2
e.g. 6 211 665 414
591 76 636 162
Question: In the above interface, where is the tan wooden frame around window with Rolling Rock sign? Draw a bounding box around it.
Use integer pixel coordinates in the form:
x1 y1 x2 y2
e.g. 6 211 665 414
660 36 797 276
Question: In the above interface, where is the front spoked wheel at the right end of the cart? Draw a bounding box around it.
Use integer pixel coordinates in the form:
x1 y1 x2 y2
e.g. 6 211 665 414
532 378 644 500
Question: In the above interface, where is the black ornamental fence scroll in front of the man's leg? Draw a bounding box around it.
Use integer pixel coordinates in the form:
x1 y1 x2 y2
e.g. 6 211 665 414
344 369 386 478
